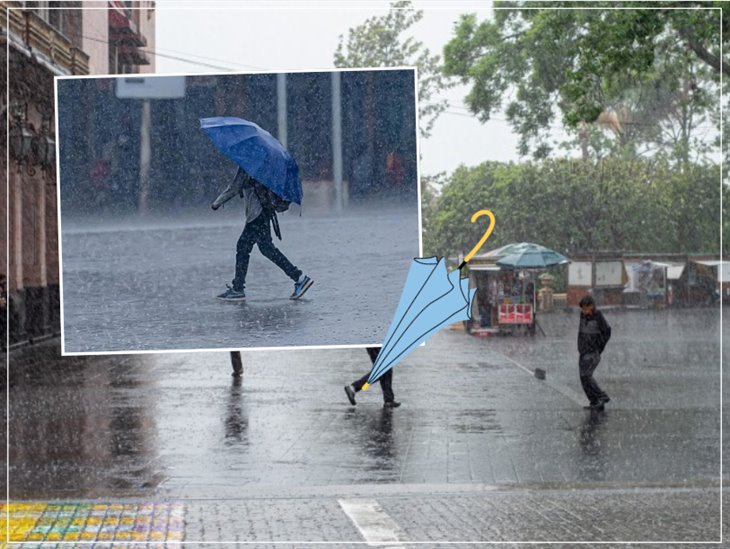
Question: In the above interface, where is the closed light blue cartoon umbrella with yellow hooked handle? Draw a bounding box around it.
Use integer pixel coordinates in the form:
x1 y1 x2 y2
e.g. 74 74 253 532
363 210 495 390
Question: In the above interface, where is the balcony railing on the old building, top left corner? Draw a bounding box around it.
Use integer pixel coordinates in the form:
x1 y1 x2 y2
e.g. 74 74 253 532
0 1 89 74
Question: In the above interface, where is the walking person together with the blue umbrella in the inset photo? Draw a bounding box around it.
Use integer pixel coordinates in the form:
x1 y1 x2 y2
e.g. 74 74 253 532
200 117 314 301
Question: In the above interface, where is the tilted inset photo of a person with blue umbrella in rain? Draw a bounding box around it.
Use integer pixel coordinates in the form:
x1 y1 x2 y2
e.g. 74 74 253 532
57 70 420 353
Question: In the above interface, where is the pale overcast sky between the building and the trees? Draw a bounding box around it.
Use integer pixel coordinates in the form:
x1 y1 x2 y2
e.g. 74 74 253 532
156 0 518 175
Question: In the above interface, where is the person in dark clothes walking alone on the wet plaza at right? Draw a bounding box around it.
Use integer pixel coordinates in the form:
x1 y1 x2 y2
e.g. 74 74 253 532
578 295 611 411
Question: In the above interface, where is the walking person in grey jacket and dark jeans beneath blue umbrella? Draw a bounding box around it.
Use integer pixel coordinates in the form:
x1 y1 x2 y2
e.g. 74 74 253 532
212 168 314 301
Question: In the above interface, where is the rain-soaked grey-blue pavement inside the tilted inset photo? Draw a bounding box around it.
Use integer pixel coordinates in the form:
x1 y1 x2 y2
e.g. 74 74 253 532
62 203 419 353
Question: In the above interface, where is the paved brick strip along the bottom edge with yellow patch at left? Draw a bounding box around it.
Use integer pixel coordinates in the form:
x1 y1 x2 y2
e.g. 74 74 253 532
2 485 729 547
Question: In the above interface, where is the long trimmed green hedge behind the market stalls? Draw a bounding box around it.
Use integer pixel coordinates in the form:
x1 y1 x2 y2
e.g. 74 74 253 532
424 158 728 256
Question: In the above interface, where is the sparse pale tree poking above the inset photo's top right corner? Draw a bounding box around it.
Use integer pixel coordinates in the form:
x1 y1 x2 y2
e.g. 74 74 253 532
335 0 449 137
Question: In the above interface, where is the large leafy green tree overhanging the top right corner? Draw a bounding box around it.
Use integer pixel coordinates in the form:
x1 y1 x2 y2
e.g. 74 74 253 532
444 2 730 163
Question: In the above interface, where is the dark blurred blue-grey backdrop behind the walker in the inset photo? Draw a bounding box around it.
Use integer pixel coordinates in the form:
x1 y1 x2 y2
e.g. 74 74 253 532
58 70 418 216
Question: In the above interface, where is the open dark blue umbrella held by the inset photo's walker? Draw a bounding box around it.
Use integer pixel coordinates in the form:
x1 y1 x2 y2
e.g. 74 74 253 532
200 116 302 205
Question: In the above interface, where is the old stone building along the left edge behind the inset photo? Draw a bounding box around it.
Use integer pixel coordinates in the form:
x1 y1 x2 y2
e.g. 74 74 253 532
0 0 155 346
